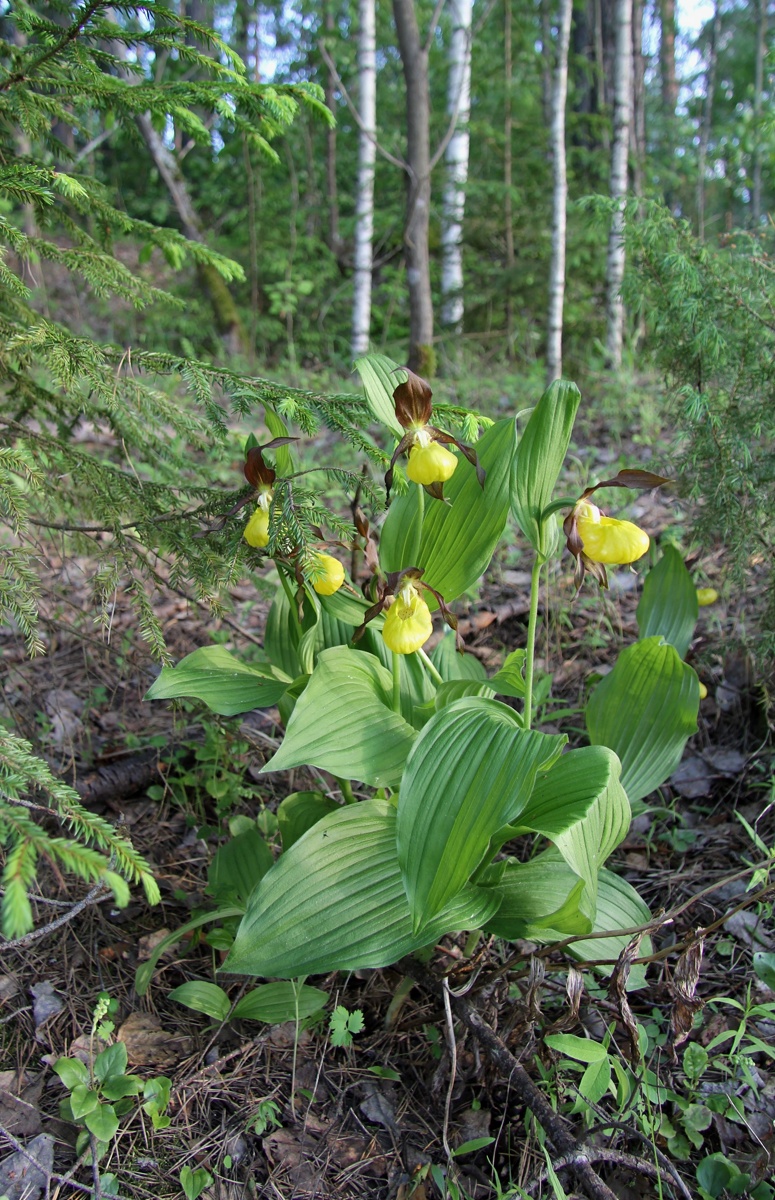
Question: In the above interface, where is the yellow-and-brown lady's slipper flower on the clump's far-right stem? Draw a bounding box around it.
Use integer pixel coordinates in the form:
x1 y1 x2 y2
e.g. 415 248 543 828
563 470 667 588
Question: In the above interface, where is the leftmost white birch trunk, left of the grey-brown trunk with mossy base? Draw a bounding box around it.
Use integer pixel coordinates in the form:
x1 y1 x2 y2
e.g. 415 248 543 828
352 0 377 356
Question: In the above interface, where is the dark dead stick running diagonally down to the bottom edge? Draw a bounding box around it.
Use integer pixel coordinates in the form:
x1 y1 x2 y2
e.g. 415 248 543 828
399 959 617 1200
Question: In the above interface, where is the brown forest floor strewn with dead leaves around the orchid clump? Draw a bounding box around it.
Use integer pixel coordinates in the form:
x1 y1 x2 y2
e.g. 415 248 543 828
0 405 775 1200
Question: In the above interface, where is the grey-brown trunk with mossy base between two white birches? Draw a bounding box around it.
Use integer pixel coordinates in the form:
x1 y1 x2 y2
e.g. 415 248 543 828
392 0 435 378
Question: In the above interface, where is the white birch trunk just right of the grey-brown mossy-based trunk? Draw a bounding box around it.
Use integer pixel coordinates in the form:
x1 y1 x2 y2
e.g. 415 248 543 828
441 0 471 334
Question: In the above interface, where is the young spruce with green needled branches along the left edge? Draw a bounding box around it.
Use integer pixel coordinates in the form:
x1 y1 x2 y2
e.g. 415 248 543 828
0 0 377 938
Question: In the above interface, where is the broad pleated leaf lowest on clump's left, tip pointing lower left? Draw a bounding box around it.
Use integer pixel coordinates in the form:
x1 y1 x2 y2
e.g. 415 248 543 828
223 800 499 978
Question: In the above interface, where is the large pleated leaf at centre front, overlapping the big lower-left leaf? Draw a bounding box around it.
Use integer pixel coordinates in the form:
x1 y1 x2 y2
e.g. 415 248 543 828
398 697 566 928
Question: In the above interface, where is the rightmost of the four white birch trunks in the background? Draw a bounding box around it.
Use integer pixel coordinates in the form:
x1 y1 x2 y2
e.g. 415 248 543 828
606 0 632 370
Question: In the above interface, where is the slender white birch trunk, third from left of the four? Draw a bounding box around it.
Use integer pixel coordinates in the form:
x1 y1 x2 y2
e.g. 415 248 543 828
546 0 573 388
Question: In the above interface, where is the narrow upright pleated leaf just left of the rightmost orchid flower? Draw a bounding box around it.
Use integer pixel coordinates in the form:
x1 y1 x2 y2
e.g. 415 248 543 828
511 379 581 558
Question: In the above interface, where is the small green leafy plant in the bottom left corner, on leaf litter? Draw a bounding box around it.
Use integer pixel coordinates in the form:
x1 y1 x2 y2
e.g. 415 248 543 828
54 992 172 1160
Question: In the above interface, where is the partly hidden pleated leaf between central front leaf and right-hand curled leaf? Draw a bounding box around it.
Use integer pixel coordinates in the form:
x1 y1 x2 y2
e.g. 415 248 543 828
480 850 593 942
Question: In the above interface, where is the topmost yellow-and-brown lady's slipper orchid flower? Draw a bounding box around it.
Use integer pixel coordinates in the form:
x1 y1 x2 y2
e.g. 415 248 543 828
385 367 485 500
